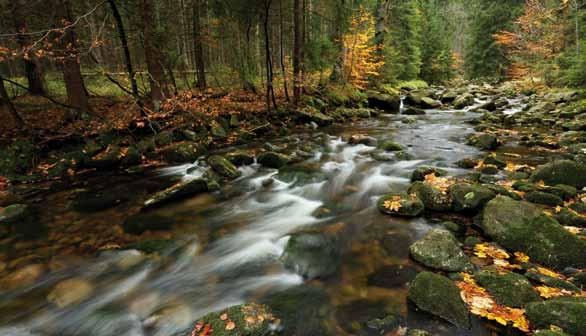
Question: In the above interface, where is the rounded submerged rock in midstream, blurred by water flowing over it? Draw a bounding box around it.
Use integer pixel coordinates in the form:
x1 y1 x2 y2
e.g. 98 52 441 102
281 232 341 279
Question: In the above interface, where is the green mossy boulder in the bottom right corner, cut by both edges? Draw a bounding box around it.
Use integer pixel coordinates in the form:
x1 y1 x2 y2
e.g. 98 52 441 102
526 297 586 336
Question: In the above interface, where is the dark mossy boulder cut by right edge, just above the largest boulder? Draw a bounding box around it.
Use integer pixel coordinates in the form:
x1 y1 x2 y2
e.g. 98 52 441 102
531 160 586 189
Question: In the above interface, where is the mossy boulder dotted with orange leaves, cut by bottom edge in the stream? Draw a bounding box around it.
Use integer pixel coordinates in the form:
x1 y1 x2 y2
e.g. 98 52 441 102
190 303 276 336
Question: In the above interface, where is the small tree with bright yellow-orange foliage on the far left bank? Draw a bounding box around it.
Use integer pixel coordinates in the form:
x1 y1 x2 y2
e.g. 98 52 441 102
343 7 385 89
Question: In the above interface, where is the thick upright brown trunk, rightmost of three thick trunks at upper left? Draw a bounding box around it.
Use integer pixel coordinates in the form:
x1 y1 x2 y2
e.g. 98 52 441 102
141 0 169 108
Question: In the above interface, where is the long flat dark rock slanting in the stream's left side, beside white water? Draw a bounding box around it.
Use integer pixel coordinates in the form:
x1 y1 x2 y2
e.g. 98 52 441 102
143 178 214 210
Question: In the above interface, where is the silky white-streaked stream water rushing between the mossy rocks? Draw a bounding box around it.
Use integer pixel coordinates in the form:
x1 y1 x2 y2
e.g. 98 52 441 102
0 96 520 336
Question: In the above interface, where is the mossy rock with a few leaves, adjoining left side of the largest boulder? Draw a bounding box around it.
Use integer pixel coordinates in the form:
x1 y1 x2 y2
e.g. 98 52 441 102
448 183 496 212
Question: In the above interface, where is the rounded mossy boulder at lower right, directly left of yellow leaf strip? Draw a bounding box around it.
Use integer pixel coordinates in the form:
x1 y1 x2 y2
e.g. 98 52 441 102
407 272 470 328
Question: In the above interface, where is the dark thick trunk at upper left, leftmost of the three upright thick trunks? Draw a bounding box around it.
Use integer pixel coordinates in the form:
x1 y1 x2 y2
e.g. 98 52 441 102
12 0 47 96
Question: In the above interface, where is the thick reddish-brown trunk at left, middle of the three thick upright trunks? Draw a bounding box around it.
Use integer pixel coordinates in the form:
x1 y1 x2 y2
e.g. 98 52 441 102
57 0 90 119
